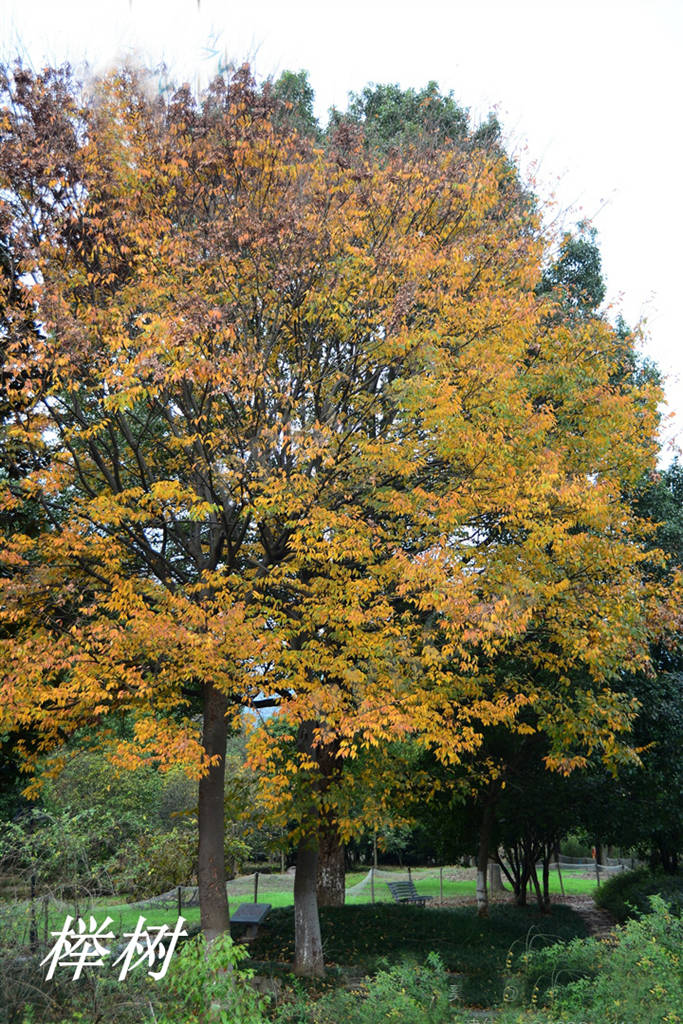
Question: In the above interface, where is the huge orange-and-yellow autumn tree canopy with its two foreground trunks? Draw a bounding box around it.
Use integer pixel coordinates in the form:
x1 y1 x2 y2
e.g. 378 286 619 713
0 69 671 973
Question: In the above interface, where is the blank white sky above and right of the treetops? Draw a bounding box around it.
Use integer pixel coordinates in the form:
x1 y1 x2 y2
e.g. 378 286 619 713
0 0 683 462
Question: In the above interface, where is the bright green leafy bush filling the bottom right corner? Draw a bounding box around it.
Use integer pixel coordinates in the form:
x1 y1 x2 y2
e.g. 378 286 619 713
511 896 683 1024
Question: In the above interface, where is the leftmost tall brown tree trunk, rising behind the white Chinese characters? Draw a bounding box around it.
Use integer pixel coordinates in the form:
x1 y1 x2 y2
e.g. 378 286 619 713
197 685 230 942
